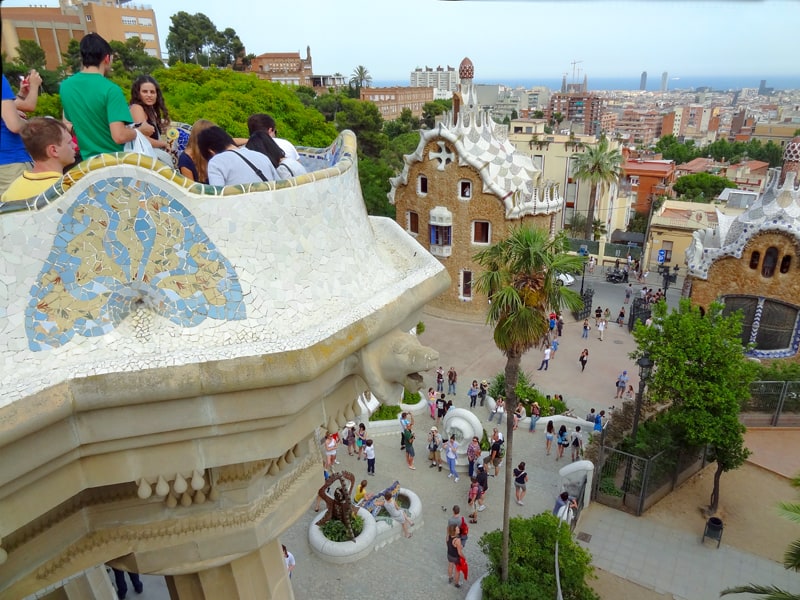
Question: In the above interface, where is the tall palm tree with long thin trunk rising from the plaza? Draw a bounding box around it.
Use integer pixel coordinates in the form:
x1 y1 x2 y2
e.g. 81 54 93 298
475 225 583 583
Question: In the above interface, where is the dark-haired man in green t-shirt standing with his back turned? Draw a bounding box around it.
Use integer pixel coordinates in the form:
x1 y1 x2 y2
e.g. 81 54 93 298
61 33 153 159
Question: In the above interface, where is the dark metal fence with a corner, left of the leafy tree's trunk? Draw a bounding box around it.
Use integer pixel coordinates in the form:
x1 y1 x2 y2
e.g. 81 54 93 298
592 447 707 517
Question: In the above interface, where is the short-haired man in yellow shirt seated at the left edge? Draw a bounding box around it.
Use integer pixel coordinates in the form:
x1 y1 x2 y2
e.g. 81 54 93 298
0 117 75 202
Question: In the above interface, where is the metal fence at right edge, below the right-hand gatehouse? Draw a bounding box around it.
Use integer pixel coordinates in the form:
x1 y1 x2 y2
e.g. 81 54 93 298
740 381 800 427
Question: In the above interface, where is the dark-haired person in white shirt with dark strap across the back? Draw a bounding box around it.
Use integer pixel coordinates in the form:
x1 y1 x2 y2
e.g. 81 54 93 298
197 126 280 186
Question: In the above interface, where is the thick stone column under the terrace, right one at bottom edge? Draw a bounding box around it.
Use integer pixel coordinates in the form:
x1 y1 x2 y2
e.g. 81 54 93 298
166 540 294 600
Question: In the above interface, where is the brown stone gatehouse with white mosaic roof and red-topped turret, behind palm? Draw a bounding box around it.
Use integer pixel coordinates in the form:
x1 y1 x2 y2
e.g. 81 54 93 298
389 59 563 319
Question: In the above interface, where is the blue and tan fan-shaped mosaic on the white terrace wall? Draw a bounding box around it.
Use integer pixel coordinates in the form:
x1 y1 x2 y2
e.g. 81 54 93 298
25 177 246 351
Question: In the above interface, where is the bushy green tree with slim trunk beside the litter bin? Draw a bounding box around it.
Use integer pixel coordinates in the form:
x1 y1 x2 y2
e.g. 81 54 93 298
633 299 757 514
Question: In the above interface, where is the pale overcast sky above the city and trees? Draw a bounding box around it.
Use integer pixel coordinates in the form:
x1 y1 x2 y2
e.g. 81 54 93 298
3 0 800 81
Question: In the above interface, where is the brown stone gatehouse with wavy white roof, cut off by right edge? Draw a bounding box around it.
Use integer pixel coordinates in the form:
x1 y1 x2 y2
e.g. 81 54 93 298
684 137 800 362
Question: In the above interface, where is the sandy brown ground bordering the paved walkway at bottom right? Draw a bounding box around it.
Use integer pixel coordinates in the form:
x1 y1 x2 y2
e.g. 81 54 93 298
591 462 800 600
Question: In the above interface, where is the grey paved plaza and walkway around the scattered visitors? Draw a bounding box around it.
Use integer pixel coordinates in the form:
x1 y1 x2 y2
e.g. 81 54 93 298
83 278 800 600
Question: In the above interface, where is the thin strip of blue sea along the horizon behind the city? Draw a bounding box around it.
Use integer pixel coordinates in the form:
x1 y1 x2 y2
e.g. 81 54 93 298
371 73 800 92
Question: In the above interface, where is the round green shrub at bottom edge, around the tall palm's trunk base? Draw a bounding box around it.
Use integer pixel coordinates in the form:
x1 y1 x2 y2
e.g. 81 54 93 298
478 512 600 600
